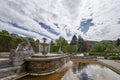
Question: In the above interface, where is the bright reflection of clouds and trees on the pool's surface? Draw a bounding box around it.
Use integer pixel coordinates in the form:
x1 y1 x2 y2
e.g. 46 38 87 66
61 61 120 80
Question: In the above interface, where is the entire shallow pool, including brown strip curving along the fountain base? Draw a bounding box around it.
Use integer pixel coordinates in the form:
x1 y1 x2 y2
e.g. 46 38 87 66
20 60 120 80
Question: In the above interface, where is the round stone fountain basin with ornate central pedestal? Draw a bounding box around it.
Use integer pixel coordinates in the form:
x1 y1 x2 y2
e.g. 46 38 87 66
25 38 70 75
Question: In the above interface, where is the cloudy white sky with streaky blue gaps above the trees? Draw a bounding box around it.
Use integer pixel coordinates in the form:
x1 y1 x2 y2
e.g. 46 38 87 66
0 0 120 41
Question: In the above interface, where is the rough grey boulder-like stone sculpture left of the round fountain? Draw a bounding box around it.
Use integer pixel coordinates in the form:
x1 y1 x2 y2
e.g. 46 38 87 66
9 41 34 66
